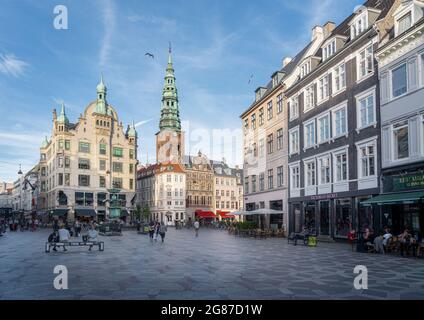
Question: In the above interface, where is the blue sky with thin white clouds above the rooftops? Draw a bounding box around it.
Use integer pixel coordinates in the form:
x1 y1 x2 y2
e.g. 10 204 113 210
0 0 364 182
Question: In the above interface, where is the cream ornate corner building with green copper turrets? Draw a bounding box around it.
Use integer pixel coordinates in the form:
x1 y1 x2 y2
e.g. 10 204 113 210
39 78 137 220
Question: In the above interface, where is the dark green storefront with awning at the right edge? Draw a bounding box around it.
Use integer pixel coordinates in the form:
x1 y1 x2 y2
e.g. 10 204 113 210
361 171 424 236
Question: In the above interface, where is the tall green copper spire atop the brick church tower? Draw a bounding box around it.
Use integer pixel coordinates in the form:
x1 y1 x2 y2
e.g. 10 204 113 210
159 44 181 131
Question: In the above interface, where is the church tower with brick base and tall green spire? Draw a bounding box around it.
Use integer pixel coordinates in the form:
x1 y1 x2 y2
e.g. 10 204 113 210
156 46 184 163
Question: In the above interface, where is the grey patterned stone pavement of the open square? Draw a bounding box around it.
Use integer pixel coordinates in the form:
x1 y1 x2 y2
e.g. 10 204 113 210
0 229 424 300
